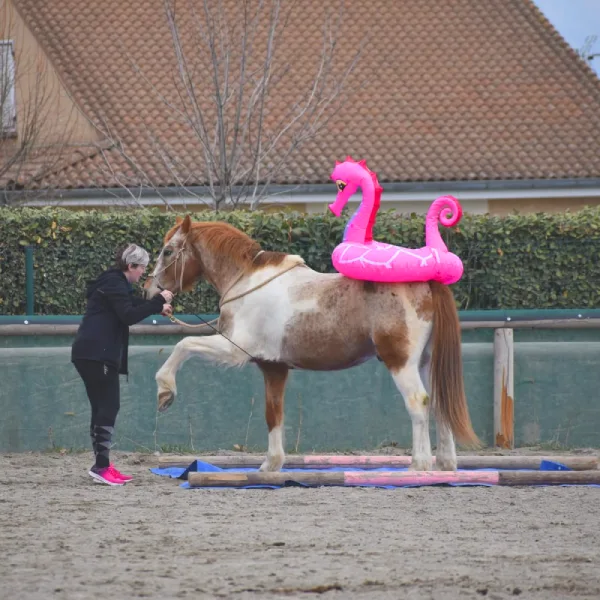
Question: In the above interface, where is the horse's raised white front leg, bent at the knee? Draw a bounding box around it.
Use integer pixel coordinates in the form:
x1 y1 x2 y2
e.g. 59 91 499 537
156 336 248 412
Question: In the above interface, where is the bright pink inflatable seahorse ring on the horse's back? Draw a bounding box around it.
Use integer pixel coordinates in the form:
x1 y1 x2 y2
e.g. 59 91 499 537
329 156 463 285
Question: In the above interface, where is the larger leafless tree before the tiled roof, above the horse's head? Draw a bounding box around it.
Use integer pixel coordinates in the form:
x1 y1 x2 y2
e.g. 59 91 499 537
99 0 364 210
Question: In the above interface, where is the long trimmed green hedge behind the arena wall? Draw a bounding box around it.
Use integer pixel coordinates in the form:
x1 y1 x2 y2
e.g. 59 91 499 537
0 208 600 314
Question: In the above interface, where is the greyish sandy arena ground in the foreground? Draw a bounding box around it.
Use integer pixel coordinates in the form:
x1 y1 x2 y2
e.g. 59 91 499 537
0 453 600 600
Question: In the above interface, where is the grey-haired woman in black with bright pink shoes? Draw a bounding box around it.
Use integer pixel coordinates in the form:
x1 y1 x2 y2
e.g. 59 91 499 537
71 244 173 485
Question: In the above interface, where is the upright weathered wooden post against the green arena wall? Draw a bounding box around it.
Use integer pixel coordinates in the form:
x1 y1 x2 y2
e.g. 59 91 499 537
494 329 515 449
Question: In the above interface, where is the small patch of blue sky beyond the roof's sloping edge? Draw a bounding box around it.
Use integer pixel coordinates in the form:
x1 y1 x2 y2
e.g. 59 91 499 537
534 0 600 77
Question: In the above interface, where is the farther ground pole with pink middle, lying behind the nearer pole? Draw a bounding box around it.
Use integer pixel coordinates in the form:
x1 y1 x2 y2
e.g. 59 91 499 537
158 454 598 471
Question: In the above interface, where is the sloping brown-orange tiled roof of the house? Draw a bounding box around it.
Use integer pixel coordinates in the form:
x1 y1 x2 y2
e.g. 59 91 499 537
7 0 600 188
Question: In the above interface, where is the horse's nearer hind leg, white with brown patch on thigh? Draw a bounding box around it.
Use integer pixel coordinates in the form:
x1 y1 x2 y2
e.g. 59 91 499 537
373 326 433 471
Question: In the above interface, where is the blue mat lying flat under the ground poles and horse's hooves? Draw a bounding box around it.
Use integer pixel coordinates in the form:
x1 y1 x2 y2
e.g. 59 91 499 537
150 460 600 489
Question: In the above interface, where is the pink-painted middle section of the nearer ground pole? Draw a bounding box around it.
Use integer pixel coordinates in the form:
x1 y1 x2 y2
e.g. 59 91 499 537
344 471 499 486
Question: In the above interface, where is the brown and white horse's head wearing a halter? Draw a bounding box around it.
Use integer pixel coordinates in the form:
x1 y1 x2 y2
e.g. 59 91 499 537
144 215 203 298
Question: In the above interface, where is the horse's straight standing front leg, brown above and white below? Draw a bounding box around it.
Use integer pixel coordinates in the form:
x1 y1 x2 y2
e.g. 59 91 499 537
258 362 289 471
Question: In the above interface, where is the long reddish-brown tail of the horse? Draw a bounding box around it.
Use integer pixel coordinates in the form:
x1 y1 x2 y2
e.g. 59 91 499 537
429 281 481 447
